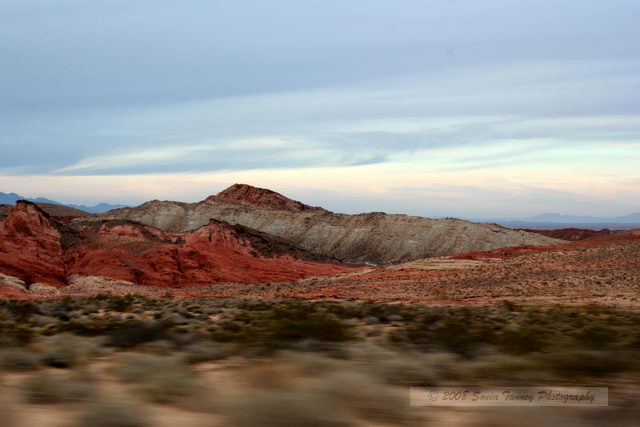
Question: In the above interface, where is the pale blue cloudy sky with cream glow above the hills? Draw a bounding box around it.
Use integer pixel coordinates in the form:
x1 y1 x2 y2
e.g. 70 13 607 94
0 0 640 218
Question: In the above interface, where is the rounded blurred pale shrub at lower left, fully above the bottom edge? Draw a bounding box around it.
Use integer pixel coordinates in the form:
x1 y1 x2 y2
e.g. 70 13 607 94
118 354 201 403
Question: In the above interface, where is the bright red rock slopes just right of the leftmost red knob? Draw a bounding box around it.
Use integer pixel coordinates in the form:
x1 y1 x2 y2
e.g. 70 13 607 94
65 221 350 287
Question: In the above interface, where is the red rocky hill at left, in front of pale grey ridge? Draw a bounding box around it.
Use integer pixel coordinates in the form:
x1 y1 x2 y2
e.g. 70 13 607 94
0 200 354 295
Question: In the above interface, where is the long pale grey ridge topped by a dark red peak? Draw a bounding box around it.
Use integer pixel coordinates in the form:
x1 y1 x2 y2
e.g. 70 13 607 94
86 184 562 265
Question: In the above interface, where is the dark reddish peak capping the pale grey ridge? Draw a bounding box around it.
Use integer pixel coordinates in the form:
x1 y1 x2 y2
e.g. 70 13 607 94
206 184 326 212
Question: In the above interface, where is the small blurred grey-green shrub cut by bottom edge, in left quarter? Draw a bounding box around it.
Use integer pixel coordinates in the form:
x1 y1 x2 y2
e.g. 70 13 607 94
76 400 151 427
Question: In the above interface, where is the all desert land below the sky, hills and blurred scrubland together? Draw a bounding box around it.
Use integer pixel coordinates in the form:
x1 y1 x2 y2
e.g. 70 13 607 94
0 184 640 426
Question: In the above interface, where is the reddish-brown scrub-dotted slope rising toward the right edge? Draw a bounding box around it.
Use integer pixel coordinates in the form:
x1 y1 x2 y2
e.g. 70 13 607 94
194 229 640 310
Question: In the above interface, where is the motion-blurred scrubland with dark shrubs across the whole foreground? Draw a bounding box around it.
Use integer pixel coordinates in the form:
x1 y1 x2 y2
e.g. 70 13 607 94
0 295 640 427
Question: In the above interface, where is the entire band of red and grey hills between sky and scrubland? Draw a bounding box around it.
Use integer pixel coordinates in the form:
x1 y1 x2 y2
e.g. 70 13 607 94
0 184 640 307
